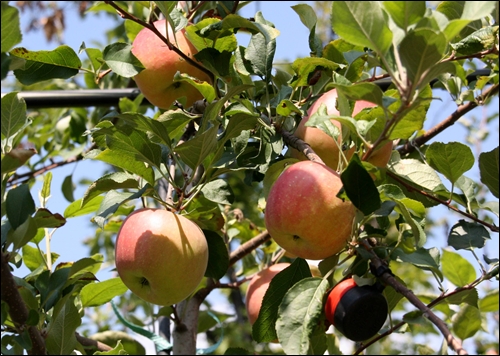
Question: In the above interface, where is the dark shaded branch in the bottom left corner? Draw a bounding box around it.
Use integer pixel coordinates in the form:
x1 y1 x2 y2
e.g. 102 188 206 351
0 252 47 355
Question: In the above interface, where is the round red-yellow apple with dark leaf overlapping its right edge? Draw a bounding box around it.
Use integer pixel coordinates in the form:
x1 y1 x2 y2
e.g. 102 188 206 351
264 161 356 260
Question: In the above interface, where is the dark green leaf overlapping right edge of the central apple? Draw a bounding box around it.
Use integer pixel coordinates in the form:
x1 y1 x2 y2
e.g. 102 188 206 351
340 154 382 215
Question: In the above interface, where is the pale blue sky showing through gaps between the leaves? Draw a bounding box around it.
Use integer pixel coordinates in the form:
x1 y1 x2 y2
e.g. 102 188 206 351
5 1 499 354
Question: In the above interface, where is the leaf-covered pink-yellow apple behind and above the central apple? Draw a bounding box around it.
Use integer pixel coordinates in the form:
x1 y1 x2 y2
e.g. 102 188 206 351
290 89 392 171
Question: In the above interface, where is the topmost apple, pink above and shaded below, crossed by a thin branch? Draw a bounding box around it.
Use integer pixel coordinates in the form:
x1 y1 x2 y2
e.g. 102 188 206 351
132 20 210 109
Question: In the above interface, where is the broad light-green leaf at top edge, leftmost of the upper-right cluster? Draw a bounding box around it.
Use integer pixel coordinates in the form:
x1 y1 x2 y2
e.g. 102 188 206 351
332 1 392 56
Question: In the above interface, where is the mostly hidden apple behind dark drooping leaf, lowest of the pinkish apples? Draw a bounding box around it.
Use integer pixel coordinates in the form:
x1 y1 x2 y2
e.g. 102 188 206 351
245 263 290 325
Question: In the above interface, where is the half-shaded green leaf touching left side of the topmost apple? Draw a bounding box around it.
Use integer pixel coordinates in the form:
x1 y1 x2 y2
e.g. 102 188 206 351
102 42 144 78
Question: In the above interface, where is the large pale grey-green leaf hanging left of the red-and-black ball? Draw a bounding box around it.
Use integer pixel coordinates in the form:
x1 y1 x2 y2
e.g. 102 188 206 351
276 277 329 355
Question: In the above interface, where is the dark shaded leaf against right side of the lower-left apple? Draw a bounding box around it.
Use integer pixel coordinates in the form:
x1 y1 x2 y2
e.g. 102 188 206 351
203 230 229 280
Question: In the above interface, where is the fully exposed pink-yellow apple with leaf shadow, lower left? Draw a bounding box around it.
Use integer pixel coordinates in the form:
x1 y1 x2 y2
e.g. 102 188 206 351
115 209 208 306
